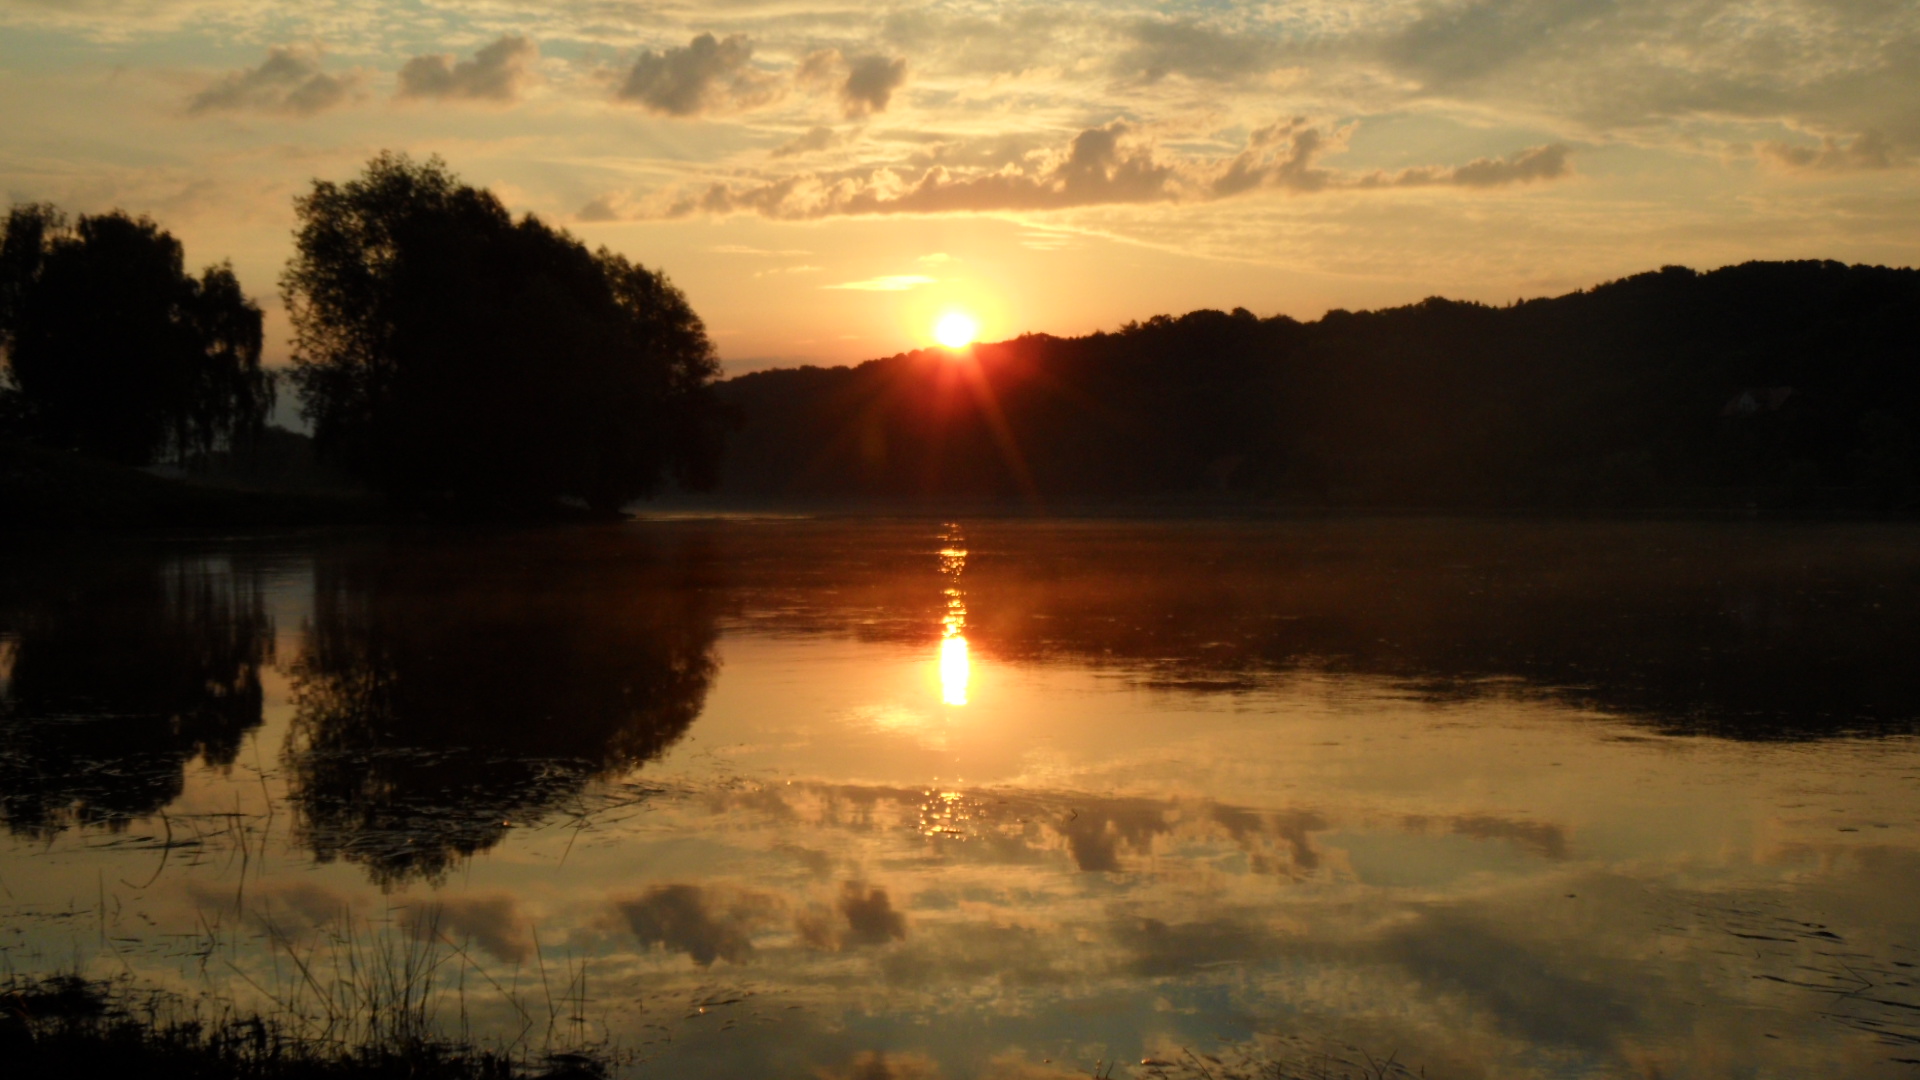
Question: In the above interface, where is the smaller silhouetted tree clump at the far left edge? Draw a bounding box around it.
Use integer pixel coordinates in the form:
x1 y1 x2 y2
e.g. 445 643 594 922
0 204 273 465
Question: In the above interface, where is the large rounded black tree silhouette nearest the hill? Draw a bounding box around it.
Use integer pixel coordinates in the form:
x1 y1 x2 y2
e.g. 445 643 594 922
284 154 720 509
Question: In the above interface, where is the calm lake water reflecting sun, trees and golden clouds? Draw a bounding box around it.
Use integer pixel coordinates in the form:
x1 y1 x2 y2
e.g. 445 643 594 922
0 519 1920 1078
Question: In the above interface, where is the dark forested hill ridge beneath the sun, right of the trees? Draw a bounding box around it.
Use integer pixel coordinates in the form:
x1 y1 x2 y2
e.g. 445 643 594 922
720 261 1920 509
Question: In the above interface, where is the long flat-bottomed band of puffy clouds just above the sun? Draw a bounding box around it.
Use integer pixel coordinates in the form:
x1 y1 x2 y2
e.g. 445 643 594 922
666 117 1569 219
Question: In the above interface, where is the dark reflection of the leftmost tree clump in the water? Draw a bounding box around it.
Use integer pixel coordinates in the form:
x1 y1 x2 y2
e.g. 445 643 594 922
0 550 273 836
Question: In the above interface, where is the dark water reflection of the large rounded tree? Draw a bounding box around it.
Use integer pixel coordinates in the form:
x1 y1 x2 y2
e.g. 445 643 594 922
284 532 718 886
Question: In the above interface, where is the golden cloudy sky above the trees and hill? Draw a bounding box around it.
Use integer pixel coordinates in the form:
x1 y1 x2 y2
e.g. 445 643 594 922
0 0 1920 373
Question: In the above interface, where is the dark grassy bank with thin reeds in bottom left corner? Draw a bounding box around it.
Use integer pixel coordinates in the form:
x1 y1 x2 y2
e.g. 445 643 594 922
0 909 618 1080
